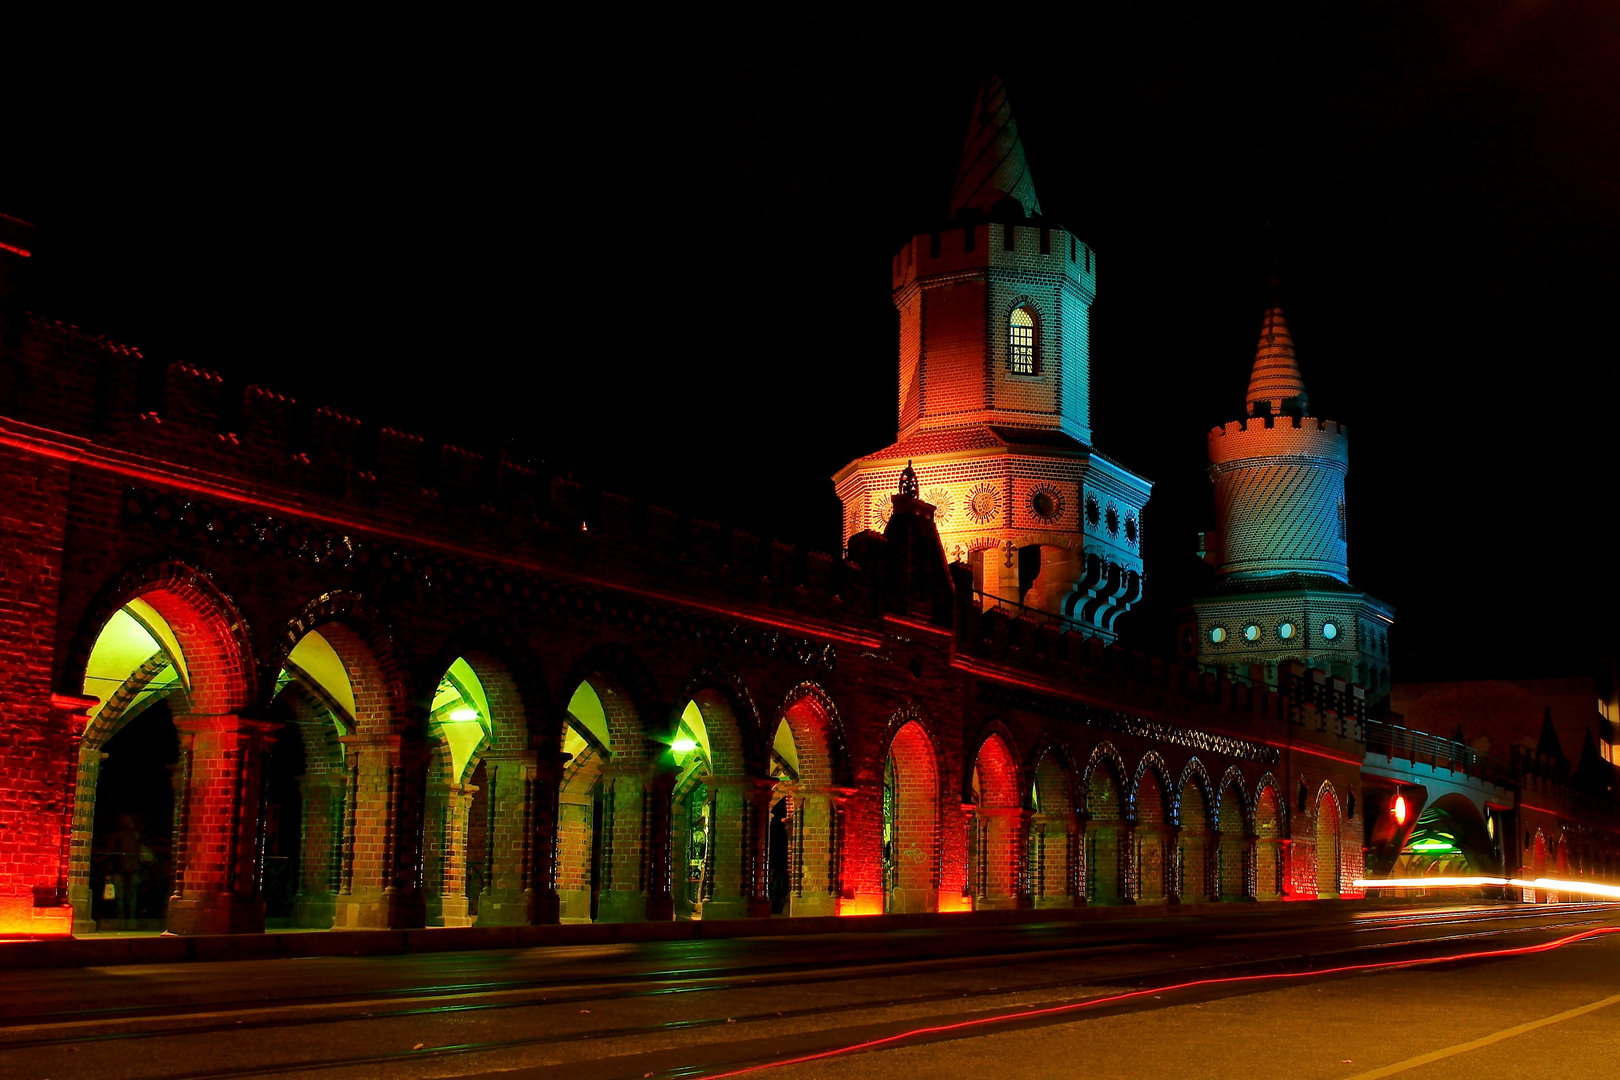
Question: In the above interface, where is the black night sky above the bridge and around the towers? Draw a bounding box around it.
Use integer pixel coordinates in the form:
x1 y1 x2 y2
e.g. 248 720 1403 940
12 3 1620 680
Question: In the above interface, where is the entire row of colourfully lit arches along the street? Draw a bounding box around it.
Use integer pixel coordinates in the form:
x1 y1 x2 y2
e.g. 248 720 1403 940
53 566 1367 933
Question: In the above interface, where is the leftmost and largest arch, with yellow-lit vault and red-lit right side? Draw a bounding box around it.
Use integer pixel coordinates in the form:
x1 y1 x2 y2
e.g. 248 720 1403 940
68 563 260 933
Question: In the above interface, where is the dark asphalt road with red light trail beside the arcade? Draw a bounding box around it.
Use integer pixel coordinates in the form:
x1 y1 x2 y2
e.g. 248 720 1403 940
0 905 1620 1080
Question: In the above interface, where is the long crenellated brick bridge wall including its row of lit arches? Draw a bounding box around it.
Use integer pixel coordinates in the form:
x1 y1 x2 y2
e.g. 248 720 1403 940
0 311 1393 933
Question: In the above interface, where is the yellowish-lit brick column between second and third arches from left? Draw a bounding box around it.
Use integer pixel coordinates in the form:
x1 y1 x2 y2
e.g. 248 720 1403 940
332 735 431 929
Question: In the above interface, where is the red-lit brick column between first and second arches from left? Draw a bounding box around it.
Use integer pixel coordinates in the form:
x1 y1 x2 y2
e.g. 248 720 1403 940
168 714 279 934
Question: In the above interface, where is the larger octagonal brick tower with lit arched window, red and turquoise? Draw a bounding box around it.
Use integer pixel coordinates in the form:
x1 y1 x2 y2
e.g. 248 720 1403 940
833 78 1152 641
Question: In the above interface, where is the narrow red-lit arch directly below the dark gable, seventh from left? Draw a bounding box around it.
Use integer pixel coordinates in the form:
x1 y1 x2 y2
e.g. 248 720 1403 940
883 721 940 913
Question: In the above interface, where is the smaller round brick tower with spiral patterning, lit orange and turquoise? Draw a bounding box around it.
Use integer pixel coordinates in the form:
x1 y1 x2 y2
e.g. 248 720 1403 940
1183 303 1395 698
